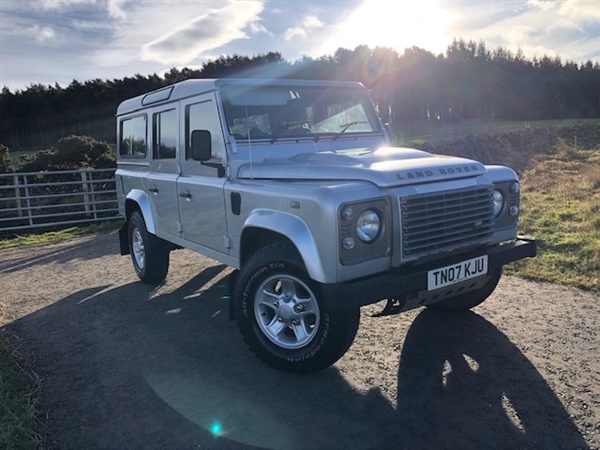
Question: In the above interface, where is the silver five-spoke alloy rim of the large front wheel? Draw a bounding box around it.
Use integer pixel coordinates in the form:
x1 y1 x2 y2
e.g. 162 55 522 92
254 275 321 350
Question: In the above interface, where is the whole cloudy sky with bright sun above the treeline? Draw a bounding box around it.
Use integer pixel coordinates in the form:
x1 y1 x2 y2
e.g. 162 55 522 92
0 0 600 92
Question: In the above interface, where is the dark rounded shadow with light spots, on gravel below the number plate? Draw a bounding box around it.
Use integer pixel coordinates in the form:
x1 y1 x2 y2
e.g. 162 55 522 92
391 310 589 449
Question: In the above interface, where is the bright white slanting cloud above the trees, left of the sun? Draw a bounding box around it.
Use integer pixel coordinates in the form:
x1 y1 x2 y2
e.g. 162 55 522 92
140 1 264 64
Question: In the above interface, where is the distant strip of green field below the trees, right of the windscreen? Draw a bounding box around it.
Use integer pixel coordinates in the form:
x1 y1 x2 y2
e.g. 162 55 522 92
393 119 600 145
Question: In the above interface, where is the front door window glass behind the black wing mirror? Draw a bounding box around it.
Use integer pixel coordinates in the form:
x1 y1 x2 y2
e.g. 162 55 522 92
185 100 225 159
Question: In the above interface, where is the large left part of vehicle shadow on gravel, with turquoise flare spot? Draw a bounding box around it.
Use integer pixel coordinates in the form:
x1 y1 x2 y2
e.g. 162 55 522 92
7 265 394 449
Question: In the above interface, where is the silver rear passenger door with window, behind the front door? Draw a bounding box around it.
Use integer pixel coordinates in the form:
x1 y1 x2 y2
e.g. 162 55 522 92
146 105 180 237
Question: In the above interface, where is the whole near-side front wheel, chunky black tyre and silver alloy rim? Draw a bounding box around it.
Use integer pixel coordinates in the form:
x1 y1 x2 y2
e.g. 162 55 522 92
234 242 360 373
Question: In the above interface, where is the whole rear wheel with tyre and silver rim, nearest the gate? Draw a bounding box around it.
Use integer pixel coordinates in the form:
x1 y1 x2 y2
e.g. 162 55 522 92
129 211 169 284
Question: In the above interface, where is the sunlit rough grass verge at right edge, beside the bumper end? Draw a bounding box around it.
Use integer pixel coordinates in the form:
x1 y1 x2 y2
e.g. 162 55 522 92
505 142 600 290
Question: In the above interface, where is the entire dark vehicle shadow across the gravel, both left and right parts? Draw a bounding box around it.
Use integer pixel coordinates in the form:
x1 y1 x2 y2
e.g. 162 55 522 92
3 266 586 449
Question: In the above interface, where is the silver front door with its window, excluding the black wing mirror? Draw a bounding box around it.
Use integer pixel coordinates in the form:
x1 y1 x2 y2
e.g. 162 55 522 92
177 94 229 253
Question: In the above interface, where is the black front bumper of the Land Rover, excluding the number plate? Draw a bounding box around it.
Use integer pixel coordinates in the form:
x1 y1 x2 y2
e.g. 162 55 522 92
321 238 537 310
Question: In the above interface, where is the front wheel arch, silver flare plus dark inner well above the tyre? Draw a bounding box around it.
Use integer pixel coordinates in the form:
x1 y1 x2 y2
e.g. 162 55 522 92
240 210 327 283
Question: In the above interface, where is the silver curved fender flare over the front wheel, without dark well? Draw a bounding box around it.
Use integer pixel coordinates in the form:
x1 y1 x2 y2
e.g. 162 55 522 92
244 209 327 283
